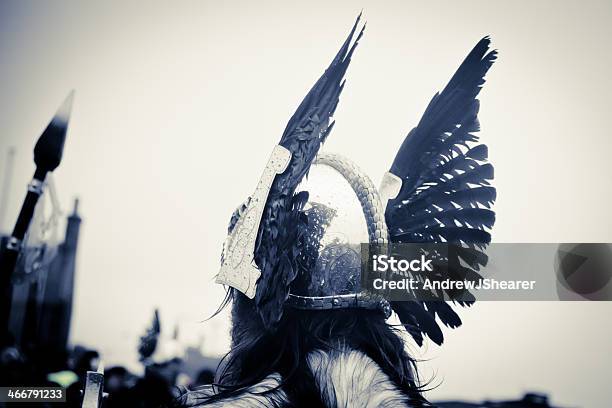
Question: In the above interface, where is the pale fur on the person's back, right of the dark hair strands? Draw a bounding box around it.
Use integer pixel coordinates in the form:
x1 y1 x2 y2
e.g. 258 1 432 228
307 349 409 408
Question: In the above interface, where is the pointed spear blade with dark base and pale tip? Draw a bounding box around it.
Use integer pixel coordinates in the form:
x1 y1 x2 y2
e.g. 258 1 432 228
34 91 74 171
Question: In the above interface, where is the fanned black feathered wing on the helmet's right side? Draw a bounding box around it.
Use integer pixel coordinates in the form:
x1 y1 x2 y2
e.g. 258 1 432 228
385 37 497 345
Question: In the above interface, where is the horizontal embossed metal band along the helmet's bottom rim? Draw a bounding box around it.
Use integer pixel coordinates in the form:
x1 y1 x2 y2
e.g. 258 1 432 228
286 292 391 319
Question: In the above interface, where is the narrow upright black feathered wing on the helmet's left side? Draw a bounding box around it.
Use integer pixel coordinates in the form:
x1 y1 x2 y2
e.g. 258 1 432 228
255 16 365 328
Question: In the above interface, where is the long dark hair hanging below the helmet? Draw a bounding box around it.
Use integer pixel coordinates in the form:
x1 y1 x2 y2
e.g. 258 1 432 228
178 289 429 407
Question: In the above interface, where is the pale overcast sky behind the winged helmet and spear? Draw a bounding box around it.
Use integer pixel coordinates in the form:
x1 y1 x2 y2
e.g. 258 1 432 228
0 0 612 407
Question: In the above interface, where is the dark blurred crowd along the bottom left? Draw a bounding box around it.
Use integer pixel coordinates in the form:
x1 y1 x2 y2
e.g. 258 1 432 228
0 313 214 408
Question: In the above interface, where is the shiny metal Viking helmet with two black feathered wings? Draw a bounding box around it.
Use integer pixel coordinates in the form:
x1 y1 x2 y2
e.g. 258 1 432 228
217 18 496 344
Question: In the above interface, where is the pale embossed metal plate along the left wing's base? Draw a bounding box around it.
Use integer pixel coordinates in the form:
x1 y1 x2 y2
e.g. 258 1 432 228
215 145 291 299
